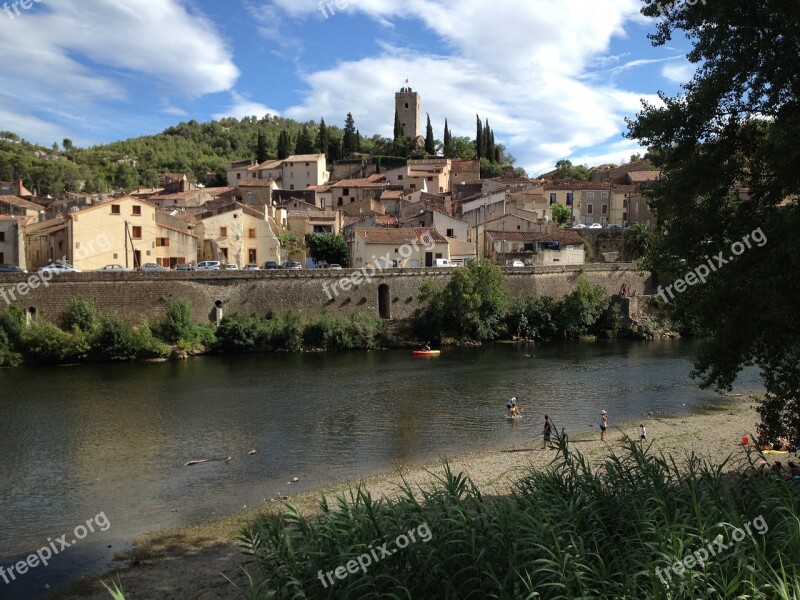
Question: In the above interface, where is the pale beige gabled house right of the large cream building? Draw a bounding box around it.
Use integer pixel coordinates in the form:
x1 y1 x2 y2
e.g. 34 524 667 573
201 202 283 268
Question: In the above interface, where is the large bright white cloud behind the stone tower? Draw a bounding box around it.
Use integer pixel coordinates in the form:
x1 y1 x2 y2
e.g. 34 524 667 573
262 0 656 172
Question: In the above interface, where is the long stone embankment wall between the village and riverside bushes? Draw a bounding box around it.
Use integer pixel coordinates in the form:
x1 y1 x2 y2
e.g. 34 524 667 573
0 264 652 322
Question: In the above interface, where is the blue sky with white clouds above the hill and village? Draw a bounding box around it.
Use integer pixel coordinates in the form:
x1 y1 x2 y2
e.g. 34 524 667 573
0 0 694 175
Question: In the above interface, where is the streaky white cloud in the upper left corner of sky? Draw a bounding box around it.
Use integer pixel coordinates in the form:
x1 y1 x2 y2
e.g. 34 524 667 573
0 0 239 143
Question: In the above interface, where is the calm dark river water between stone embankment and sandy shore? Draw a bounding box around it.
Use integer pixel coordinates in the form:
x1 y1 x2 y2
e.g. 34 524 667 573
0 340 761 598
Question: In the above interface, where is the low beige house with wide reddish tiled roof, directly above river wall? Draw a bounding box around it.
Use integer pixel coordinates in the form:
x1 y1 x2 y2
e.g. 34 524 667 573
350 227 450 269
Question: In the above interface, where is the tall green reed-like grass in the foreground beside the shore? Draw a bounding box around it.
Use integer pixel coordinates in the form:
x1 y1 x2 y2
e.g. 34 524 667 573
240 437 800 600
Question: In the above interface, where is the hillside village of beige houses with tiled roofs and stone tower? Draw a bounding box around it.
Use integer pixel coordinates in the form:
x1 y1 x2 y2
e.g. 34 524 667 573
0 87 659 272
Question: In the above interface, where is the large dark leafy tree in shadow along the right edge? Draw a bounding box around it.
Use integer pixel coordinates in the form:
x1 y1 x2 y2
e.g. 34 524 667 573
627 0 800 439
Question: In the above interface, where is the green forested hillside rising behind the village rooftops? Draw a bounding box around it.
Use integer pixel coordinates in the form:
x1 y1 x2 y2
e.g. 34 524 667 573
0 114 514 196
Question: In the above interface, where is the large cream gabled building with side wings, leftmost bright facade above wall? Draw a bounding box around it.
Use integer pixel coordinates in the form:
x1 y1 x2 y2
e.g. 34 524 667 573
25 196 198 271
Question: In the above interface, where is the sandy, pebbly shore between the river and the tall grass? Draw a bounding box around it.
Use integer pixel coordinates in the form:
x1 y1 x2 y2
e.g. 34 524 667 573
54 398 770 600
